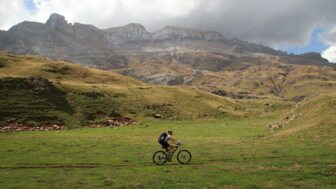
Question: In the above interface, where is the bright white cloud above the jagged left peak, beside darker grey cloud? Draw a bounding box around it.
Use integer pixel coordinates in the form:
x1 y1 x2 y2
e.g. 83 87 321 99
24 0 200 28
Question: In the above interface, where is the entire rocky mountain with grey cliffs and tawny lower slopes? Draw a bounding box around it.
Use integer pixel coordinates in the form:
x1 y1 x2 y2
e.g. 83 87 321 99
0 13 335 96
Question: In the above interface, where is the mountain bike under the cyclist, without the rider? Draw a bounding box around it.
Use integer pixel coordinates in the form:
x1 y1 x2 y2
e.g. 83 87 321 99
153 142 191 165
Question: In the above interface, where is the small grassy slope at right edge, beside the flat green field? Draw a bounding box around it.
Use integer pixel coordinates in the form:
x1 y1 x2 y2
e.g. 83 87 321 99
270 91 336 140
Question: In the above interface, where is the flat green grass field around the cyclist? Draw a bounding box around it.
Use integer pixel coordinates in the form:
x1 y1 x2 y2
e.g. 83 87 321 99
0 117 336 188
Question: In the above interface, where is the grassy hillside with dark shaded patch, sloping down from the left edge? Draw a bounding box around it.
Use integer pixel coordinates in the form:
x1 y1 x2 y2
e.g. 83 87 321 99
0 53 248 127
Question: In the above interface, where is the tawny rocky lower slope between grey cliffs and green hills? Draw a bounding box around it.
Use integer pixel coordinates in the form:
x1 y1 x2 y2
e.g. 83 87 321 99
115 51 336 99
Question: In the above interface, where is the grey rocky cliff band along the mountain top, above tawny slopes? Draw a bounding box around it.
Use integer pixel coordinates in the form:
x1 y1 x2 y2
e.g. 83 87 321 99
0 13 326 63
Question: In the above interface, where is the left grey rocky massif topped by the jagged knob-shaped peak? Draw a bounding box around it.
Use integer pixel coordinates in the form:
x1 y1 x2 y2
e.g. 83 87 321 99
0 14 125 67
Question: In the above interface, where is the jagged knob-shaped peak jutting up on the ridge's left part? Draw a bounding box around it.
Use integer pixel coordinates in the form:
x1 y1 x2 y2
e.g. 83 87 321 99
46 13 73 33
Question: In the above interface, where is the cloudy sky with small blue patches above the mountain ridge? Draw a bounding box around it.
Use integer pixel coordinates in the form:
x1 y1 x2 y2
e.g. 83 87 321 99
0 0 336 63
